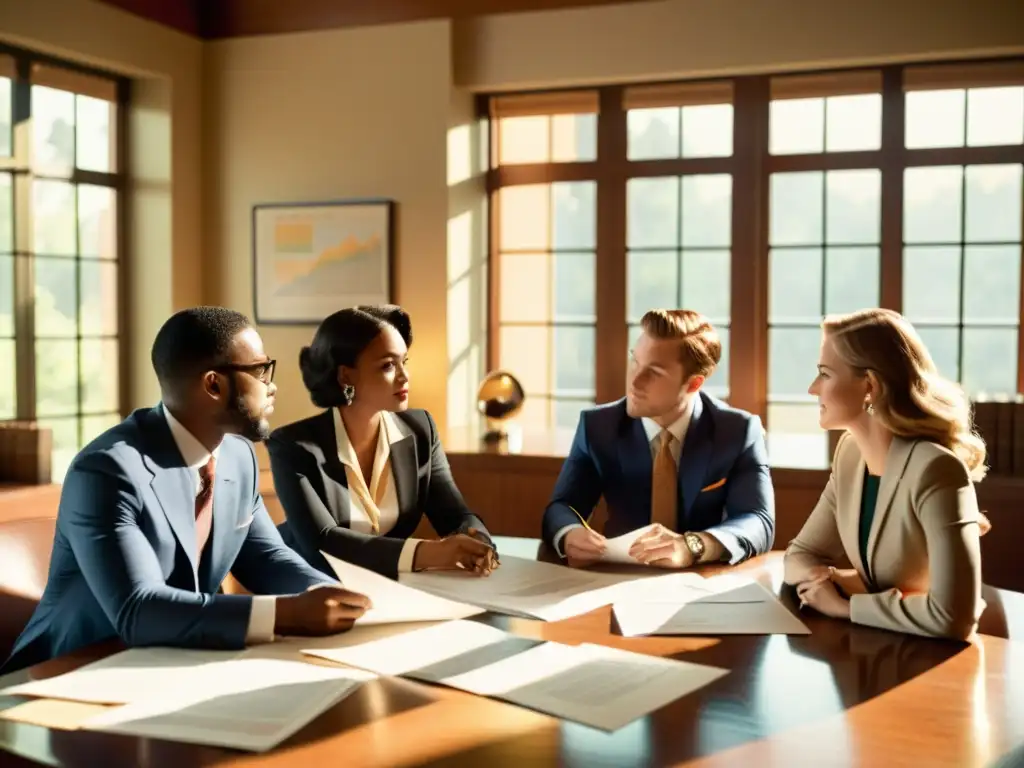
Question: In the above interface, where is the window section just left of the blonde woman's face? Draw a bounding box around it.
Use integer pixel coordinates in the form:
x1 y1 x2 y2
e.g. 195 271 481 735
767 73 882 468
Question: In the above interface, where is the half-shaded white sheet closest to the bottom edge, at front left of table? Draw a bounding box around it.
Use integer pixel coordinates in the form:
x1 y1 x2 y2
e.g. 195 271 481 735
82 658 374 752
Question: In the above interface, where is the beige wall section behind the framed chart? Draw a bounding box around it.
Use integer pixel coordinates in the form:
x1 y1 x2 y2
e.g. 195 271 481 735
204 22 452 462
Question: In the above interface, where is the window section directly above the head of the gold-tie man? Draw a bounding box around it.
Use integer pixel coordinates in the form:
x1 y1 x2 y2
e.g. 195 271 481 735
624 83 733 398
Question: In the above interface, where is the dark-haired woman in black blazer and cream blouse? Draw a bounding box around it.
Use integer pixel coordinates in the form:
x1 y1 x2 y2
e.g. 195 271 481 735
267 305 498 579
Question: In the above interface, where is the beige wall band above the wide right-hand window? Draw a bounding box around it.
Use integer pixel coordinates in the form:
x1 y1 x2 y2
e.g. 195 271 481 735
455 0 1024 90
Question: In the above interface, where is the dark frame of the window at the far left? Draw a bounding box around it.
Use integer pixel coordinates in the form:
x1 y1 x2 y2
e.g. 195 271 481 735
0 44 132 442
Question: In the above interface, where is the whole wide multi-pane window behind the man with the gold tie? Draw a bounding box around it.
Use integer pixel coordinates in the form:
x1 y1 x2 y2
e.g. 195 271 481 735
489 59 1024 468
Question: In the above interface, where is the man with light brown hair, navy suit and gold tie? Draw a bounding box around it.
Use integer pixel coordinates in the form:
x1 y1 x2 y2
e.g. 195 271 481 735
543 309 775 568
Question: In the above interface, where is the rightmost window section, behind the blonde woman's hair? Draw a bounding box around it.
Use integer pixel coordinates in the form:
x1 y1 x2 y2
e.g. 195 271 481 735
902 66 1024 396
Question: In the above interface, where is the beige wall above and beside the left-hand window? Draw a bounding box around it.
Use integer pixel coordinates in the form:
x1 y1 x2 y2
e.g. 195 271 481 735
0 0 203 408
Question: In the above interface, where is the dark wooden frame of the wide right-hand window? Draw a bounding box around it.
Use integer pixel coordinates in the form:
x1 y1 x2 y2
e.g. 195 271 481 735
477 56 1024 463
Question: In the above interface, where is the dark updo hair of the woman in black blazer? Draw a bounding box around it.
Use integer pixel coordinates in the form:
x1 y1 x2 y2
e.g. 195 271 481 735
299 304 413 409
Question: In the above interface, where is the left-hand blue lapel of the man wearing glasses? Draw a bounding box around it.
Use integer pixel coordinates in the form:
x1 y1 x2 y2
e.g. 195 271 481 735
144 407 198 588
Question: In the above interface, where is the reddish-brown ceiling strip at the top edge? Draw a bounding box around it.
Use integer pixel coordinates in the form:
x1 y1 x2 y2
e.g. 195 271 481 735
99 0 646 40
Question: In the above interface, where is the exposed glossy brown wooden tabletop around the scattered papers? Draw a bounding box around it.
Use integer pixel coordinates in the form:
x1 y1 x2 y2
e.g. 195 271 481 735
0 537 1024 768
